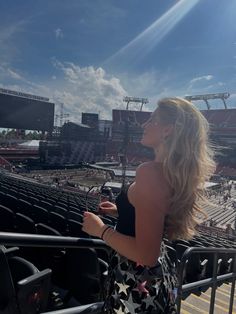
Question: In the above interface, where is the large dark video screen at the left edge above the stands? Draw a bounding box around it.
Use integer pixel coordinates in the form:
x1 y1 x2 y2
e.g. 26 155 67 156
0 93 54 132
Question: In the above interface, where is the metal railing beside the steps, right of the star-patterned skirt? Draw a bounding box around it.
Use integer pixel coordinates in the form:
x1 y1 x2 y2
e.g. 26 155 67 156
177 247 236 314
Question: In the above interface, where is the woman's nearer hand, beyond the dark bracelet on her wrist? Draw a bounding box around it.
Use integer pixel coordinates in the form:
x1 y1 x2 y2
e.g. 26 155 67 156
82 212 105 238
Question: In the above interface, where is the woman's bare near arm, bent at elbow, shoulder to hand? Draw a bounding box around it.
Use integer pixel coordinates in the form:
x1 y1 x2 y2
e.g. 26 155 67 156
83 166 166 266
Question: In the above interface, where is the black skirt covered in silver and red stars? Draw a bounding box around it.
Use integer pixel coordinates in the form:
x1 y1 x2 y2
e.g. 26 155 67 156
101 243 177 314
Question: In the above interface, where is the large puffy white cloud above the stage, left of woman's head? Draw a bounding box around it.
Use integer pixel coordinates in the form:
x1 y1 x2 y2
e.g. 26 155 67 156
53 59 127 121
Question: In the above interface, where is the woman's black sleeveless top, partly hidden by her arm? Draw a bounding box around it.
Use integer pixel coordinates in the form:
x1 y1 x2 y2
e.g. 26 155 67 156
116 186 135 237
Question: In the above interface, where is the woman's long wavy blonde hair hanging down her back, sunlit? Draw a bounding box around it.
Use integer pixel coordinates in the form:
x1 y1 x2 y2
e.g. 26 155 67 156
157 98 215 240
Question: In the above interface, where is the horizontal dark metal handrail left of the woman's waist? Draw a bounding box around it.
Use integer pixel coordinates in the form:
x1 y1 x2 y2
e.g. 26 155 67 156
0 232 111 252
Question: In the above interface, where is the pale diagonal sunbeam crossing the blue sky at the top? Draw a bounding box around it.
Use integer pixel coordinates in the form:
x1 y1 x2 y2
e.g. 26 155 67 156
105 0 200 64
